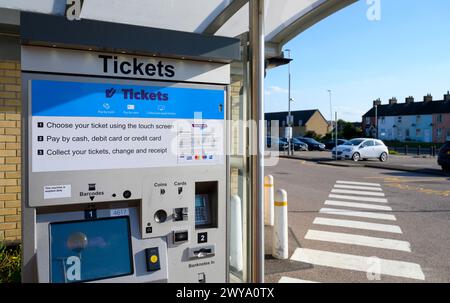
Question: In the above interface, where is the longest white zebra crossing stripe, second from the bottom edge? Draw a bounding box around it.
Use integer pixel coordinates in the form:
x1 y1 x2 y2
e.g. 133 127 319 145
291 248 425 280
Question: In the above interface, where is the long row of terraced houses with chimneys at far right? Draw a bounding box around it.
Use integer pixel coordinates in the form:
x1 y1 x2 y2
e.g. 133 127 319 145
362 92 450 143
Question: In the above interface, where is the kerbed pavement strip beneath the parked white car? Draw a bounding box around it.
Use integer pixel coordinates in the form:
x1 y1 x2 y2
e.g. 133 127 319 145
280 151 448 176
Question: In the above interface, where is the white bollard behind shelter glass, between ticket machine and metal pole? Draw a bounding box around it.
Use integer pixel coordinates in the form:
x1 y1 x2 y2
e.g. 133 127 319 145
230 195 243 271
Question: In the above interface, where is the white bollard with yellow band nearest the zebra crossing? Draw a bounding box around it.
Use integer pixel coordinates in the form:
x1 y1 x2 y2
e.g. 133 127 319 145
272 189 289 259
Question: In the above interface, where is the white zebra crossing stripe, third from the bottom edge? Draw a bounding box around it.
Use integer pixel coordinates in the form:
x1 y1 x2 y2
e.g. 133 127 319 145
305 229 411 252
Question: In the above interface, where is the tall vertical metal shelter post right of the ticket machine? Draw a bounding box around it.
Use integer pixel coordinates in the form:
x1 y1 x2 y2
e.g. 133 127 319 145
249 0 264 283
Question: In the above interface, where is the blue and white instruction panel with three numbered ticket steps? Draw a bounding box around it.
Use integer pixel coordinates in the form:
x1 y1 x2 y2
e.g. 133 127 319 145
30 80 226 172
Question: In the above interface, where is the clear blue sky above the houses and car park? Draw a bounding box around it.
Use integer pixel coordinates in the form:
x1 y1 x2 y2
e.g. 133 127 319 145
265 0 450 122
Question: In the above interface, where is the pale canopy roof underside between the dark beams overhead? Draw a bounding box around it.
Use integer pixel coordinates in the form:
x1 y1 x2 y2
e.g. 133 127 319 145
0 0 357 46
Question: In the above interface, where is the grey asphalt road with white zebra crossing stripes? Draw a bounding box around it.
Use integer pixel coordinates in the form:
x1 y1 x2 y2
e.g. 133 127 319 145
265 159 450 283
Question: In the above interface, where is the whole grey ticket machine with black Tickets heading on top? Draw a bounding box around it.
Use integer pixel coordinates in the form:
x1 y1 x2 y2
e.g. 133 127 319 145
22 12 239 283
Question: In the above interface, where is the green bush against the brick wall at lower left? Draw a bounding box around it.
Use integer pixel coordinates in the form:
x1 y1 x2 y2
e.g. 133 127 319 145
0 243 21 283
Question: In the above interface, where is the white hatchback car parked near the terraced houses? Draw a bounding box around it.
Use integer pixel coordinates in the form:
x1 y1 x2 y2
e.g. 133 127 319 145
331 138 389 162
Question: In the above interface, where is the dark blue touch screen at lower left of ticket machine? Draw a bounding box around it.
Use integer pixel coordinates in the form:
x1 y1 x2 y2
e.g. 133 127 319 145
49 216 133 283
